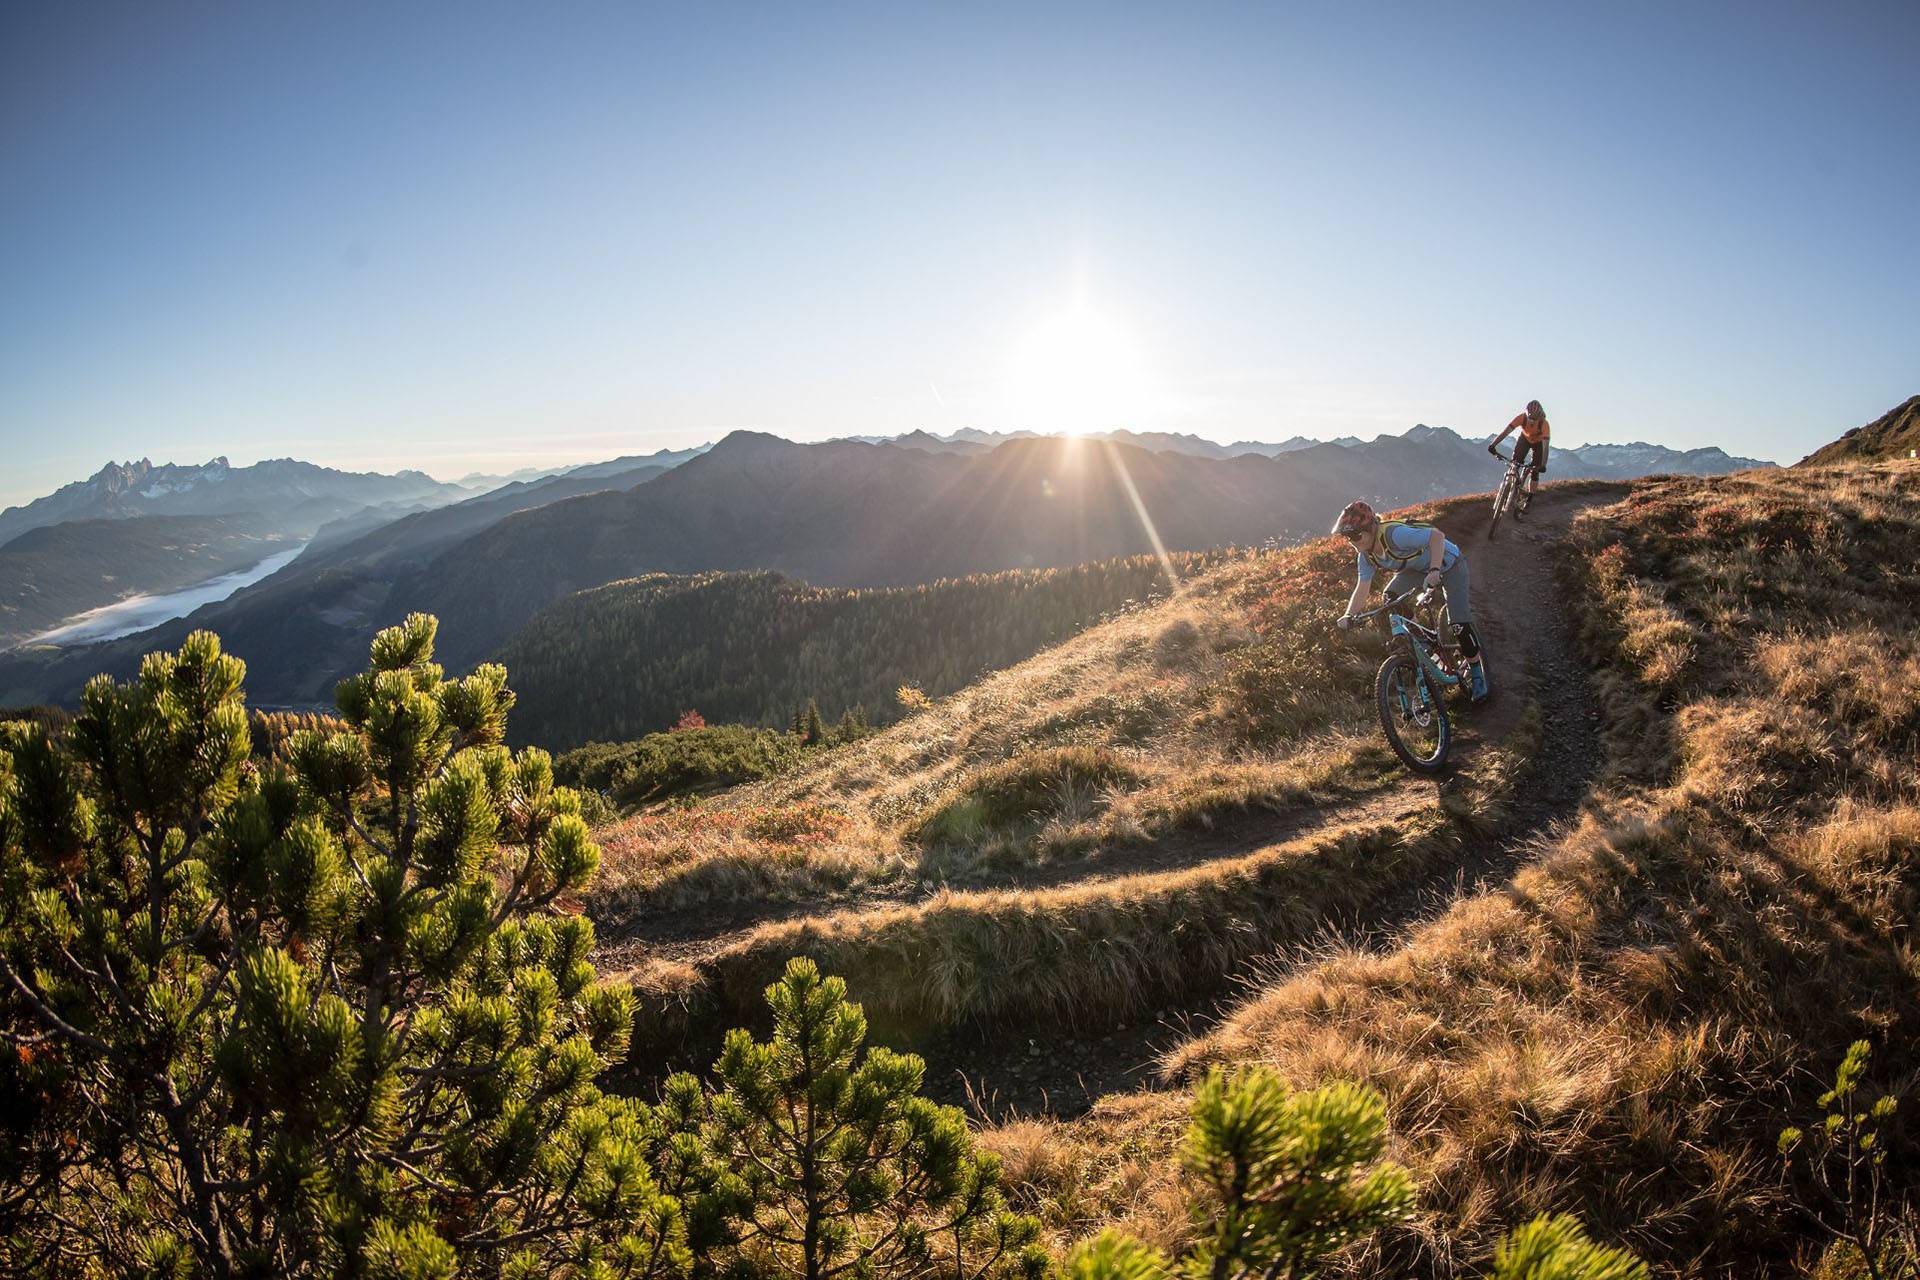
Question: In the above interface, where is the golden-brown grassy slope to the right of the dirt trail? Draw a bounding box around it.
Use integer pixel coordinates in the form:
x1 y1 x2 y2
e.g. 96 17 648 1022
993 462 1920 1274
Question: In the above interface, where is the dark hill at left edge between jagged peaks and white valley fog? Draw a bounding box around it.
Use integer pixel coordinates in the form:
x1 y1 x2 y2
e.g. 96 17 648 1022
0 514 298 649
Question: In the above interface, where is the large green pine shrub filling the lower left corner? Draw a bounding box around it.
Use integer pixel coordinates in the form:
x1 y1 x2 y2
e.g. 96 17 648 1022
0 616 687 1278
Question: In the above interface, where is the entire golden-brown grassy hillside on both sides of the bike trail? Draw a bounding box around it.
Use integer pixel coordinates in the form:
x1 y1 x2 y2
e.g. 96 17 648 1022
588 462 1920 1276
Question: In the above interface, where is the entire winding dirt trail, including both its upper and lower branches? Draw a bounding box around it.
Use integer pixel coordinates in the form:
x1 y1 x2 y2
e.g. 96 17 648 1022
595 486 1624 1119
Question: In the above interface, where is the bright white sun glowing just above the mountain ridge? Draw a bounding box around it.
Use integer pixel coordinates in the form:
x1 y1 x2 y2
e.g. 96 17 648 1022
1010 305 1146 436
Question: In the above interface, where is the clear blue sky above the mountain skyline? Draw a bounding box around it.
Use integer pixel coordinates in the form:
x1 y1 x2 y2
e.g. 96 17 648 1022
0 0 1920 503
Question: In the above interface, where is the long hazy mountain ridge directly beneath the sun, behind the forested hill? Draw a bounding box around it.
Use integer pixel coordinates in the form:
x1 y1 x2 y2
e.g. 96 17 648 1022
0 426 1774 706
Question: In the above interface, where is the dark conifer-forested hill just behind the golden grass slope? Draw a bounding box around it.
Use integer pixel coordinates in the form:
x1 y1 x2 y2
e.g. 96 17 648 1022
497 555 1208 750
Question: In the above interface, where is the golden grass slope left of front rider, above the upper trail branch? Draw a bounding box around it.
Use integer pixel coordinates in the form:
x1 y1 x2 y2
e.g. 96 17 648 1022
589 525 1396 929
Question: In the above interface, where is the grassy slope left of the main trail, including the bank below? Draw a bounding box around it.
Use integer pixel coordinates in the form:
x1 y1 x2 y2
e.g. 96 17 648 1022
588 503 1559 1055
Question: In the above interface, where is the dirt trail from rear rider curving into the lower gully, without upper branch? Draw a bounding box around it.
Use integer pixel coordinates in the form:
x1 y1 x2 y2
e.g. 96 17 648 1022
914 489 1620 1121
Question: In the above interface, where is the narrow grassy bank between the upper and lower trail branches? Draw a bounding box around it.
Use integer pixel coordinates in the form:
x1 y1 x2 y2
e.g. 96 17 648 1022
614 718 1536 1074
